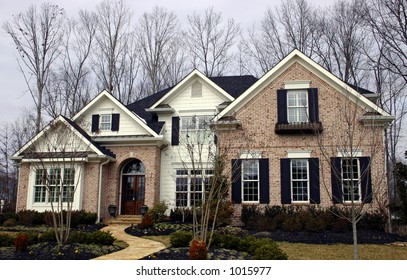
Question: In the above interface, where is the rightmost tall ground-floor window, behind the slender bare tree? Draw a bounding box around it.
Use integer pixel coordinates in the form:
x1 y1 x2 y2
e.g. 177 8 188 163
342 158 361 202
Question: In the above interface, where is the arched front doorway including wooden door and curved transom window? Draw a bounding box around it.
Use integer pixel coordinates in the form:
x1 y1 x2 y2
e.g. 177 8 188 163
121 159 145 215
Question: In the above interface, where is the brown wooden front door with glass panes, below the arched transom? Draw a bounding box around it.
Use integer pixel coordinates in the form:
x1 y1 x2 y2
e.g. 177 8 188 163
121 175 145 215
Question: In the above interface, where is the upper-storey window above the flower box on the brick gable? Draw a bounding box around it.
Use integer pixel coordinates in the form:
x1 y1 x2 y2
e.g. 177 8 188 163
287 90 308 123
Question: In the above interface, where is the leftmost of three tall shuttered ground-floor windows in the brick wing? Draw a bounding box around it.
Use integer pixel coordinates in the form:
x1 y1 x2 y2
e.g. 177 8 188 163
242 160 259 202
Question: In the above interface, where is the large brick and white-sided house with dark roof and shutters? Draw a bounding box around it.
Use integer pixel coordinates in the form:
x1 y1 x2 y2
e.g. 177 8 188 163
13 50 394 222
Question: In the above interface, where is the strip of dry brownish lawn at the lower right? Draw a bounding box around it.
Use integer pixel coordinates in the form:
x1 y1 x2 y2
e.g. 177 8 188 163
278 242 407 260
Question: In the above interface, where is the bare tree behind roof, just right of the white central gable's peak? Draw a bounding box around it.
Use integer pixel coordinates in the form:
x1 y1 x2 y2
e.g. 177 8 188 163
185 7 240 77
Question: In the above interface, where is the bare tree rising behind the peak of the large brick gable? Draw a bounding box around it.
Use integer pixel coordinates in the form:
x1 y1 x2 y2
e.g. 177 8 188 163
240 0 320 76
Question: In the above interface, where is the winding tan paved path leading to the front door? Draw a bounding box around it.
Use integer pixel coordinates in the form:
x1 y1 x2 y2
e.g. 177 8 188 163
94 225 165 260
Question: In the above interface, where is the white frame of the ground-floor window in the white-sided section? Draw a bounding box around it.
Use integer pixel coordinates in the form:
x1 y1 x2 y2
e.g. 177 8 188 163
175 168 213 207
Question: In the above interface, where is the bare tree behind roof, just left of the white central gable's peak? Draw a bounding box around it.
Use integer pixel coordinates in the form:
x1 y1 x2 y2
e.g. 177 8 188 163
135 7 183 94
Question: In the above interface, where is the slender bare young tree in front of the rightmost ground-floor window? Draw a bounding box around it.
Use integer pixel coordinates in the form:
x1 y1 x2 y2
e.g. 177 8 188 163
316 95 390 259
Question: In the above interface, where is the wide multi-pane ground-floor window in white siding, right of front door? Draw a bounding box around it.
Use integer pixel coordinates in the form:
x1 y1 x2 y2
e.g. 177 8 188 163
175 169 213 207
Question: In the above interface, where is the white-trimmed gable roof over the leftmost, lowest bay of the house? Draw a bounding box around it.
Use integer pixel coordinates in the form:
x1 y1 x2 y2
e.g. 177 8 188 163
12 115 116 160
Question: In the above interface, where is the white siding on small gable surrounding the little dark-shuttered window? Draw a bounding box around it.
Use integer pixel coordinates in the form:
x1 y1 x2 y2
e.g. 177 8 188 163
76 97 150 136
